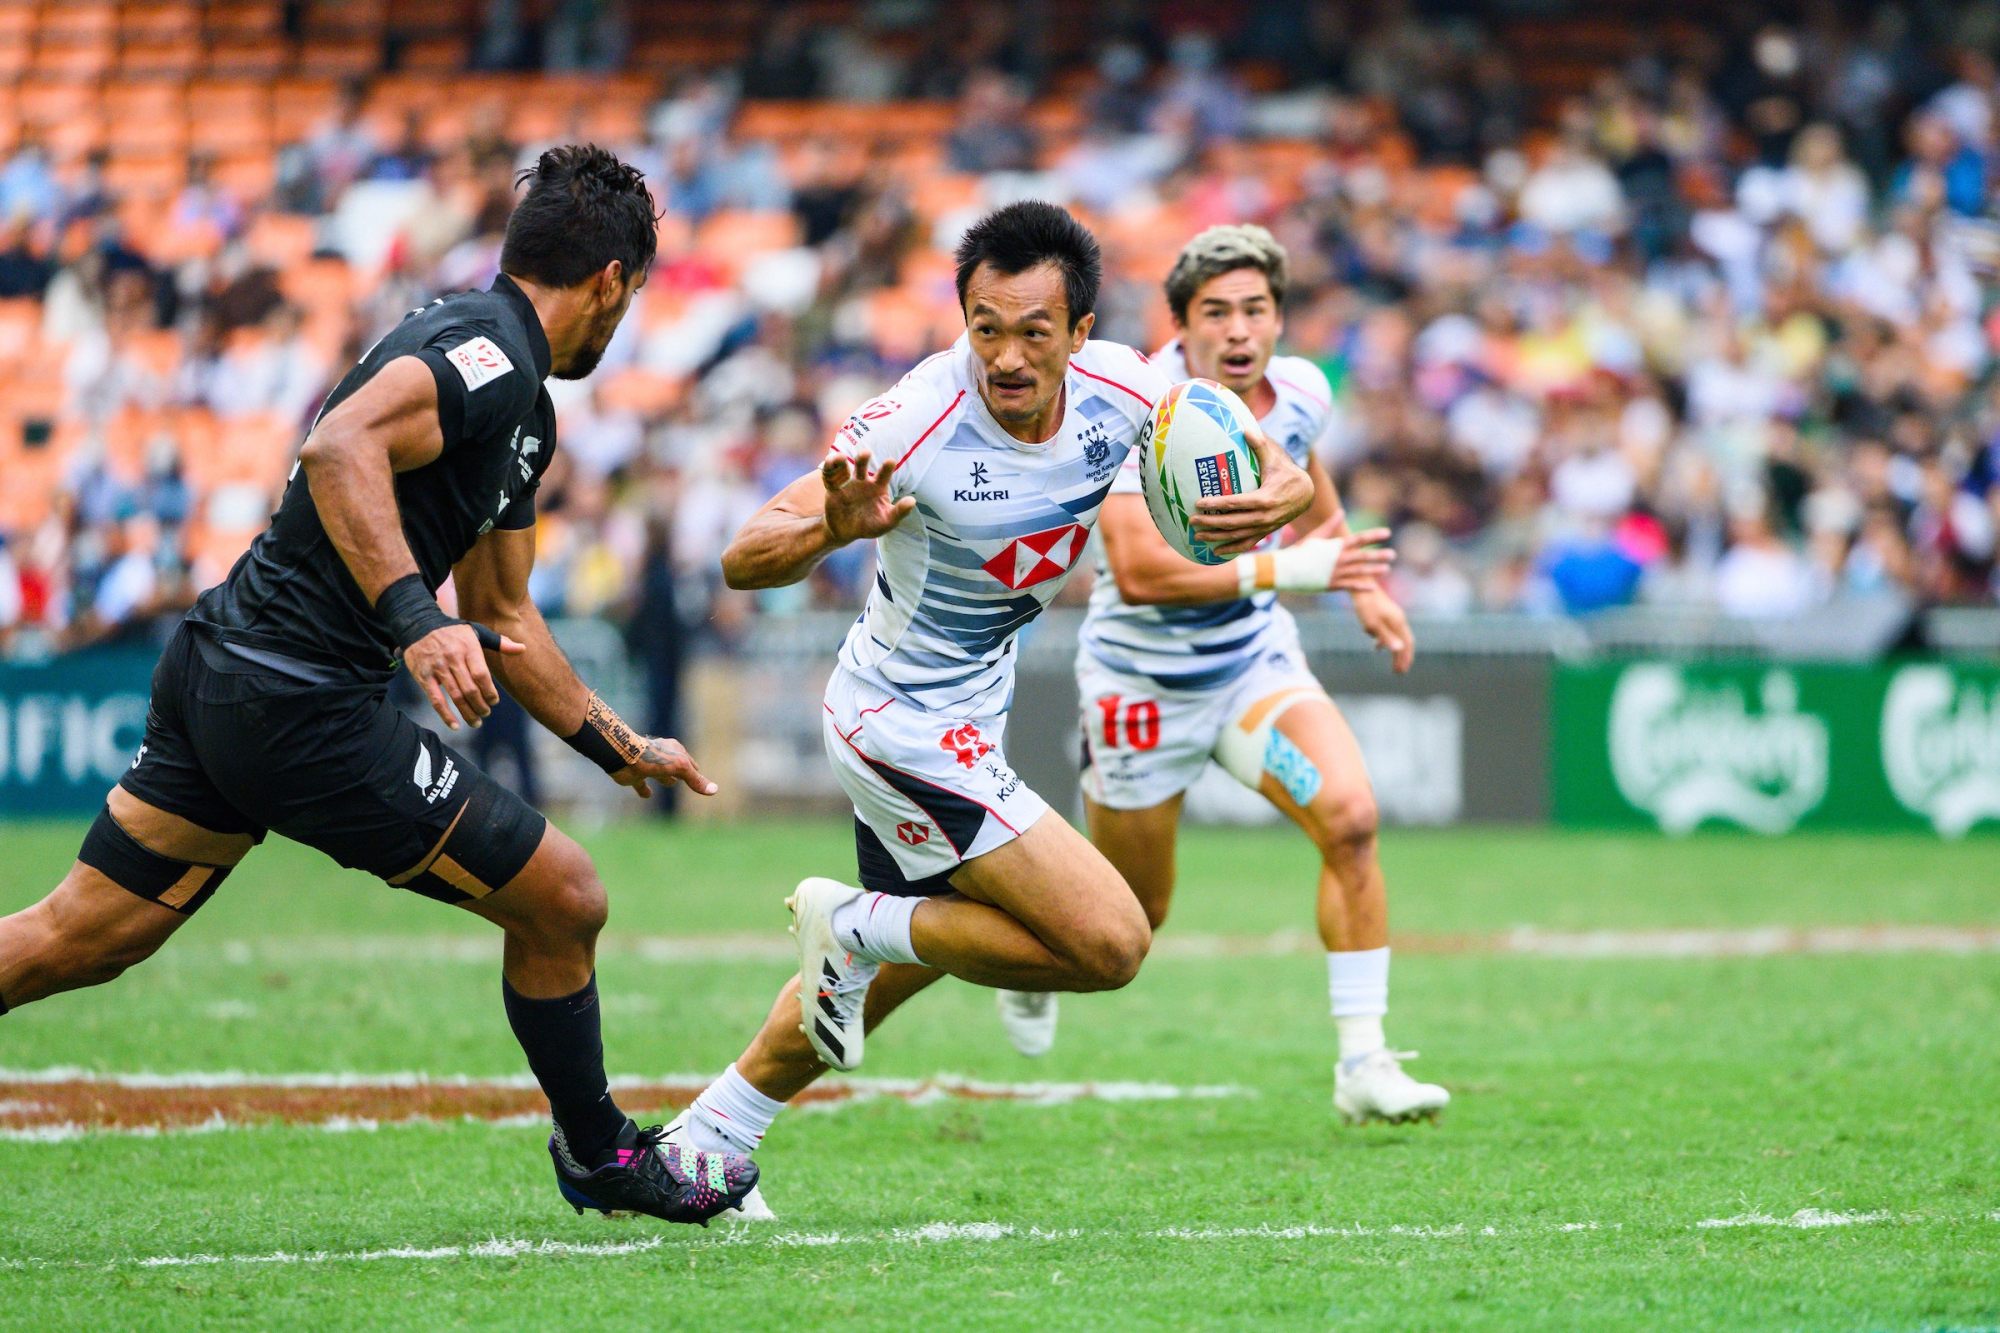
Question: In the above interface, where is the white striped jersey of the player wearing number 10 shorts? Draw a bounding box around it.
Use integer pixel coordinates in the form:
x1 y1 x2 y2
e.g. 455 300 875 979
1082 340 1334 693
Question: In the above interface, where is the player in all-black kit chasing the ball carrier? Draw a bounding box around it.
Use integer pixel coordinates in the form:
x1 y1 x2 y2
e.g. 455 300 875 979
0 146 756 1223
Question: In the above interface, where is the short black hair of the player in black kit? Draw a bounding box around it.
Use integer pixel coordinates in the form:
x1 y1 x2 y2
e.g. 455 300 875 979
500 144 660 286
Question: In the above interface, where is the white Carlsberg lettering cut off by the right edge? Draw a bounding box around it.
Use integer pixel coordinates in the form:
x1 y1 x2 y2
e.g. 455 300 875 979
1882 667 2000 839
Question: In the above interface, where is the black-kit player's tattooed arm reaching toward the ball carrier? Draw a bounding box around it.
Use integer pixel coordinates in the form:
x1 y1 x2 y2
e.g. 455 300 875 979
452 526 716 797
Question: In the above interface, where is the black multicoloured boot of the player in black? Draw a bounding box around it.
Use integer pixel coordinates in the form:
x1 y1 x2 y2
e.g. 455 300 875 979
548 1121 758 1227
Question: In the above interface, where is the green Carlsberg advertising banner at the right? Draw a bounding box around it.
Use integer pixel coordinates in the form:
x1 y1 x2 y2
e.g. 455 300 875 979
1550 662 2000 839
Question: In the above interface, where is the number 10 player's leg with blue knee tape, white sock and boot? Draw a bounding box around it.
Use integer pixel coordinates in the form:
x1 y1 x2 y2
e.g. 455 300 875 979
1258 697 1450 1123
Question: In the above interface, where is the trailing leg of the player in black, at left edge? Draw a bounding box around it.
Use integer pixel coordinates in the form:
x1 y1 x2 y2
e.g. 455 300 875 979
0 787 252 1013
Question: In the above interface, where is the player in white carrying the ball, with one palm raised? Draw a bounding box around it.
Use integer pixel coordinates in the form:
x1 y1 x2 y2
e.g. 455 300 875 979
668 202 1382 1215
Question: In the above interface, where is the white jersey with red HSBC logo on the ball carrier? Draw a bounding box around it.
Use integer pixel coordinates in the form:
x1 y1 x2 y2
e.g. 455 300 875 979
834 334 1168 717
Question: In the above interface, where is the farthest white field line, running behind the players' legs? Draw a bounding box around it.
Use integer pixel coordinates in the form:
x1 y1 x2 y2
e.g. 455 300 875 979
176 925 2000 967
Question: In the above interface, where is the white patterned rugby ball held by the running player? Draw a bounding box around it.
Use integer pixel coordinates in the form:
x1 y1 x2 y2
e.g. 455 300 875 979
1138 380 1262 564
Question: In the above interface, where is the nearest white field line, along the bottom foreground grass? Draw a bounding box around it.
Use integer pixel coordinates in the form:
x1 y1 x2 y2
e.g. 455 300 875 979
0 1209 2000 1271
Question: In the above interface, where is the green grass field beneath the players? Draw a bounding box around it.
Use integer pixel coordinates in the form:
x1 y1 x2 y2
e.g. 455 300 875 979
0 808 2000 1329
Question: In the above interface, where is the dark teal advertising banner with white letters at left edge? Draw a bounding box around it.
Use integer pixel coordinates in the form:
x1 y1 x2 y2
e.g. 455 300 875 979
0 648 158 819
